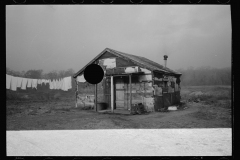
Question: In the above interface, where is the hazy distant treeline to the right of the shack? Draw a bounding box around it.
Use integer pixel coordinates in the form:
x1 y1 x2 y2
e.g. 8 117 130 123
177 67 231 86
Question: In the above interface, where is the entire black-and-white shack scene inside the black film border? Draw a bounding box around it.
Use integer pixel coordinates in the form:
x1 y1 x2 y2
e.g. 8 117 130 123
6 5 233 156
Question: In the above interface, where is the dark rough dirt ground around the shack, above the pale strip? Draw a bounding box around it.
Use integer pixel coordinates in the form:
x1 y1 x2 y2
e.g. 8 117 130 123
6 86 232 130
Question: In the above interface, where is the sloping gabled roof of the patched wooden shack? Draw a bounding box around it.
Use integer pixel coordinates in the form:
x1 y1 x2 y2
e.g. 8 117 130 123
73 48 181 78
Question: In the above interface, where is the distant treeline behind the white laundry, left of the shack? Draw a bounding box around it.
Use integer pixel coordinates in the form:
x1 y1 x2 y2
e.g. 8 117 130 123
6 68 75 79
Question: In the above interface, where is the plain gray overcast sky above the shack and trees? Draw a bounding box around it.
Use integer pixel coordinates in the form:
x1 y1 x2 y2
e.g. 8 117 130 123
6 5 232 72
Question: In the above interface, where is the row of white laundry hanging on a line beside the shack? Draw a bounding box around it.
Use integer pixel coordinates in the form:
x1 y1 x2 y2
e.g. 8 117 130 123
6 74 72 91
